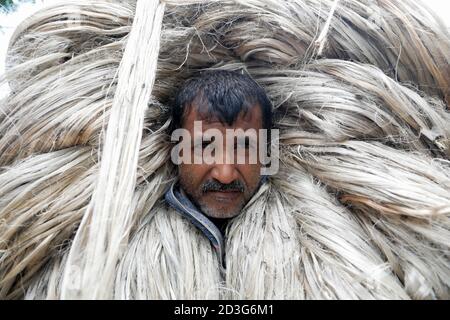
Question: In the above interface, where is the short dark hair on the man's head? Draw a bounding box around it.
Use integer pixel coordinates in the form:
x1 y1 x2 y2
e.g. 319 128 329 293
172 70 272 129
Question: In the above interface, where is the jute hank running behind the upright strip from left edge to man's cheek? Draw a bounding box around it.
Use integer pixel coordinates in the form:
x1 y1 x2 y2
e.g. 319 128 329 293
0 126 171 297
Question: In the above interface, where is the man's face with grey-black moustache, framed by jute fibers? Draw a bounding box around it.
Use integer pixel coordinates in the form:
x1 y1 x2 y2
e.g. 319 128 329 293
179 104 263 218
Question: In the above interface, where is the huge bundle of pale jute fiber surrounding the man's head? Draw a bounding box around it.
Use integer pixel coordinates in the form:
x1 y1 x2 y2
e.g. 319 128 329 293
0 0 450 299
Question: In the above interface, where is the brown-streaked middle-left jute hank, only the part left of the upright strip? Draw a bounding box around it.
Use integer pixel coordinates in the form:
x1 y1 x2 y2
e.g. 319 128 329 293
0 148 94 297
